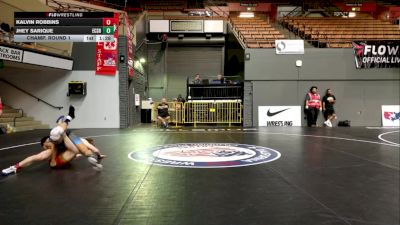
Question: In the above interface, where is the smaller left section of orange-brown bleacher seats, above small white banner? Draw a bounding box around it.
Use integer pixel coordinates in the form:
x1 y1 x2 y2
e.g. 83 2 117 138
231 17 285 48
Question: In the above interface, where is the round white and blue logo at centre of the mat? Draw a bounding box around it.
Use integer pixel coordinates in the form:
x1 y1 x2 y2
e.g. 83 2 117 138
128 143 281 168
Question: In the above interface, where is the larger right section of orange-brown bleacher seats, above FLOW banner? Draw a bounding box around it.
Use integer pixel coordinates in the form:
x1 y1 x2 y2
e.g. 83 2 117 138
284 17 400 48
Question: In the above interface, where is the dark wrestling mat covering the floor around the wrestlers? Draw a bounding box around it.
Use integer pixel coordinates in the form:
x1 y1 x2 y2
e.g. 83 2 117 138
0 127 400 225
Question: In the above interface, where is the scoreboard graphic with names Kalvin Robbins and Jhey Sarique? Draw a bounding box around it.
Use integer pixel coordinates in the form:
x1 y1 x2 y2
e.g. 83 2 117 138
14 12 119 42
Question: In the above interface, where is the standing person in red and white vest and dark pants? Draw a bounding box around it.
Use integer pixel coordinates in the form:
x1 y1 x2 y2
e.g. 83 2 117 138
305 86 322 127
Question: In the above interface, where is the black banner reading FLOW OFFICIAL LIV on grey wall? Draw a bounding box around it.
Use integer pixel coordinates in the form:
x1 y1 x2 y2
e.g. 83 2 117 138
352 40 400 69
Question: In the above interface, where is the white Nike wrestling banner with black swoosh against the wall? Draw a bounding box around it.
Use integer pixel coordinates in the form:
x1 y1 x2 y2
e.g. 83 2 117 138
258 106 301 127
